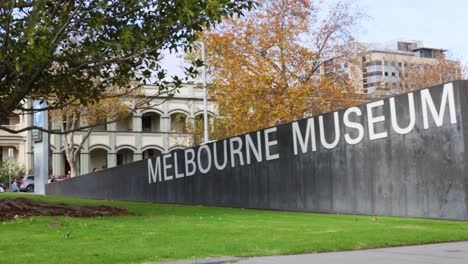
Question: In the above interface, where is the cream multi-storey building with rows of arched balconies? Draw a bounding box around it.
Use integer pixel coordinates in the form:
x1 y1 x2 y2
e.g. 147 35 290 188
0 84 215 176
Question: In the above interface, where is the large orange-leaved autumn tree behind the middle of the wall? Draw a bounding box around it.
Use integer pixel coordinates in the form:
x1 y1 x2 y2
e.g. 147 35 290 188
199 0 363 137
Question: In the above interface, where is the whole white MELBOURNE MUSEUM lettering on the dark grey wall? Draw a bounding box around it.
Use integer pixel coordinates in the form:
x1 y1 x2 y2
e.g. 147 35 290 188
147 83 457 184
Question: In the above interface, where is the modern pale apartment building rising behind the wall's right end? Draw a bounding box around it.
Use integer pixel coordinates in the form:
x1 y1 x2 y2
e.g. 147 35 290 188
323 40 461 95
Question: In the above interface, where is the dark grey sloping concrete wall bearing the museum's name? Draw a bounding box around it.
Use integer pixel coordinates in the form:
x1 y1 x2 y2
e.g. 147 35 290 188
46 81 468 220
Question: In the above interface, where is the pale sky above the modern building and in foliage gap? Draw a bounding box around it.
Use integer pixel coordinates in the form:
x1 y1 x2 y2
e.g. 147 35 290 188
164 0 468 75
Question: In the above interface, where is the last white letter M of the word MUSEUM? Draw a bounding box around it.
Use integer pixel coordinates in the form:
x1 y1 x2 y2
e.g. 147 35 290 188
421 83 457 129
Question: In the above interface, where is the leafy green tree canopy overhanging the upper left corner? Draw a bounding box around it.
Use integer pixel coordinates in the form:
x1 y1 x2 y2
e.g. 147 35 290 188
0 0 253 130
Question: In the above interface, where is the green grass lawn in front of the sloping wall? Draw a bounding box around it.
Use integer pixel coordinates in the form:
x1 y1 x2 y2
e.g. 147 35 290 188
0 193 468 263
